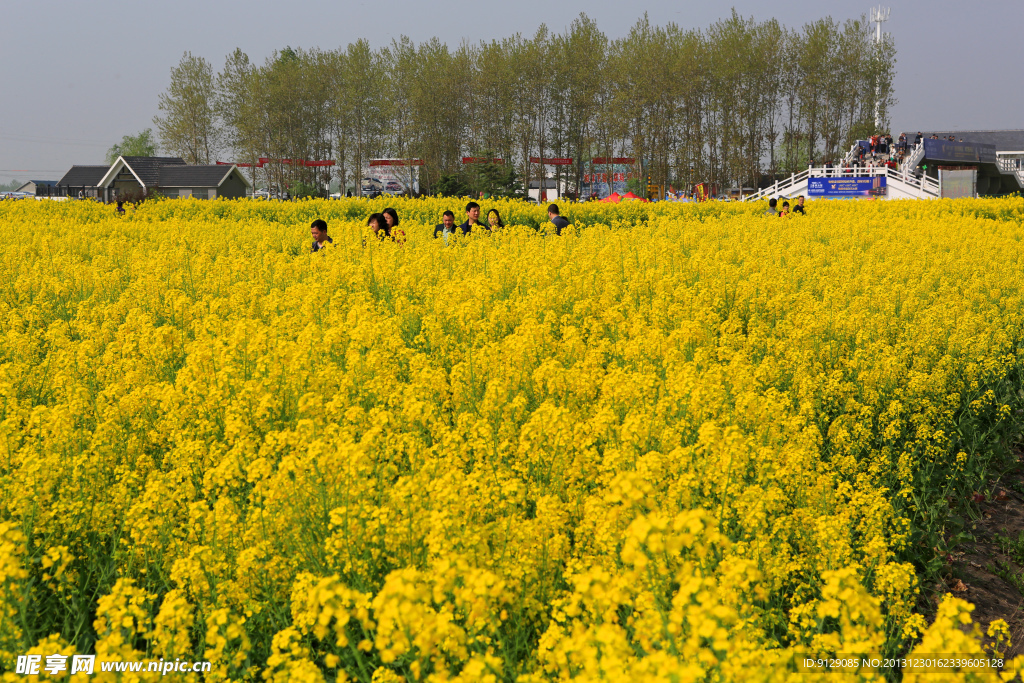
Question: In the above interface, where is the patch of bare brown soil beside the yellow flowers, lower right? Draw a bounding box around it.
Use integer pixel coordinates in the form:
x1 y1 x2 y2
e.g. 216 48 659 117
931 446 1024 656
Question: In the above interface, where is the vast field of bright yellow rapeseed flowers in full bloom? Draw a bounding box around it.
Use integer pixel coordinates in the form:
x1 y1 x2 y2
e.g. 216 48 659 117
0 194 1024 683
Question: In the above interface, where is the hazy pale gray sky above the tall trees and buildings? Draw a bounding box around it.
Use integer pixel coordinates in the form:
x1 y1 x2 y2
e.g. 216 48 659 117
0 0 1024 182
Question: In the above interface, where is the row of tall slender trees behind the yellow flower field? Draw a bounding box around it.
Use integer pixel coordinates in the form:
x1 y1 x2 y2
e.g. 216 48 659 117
154 10 896 194
